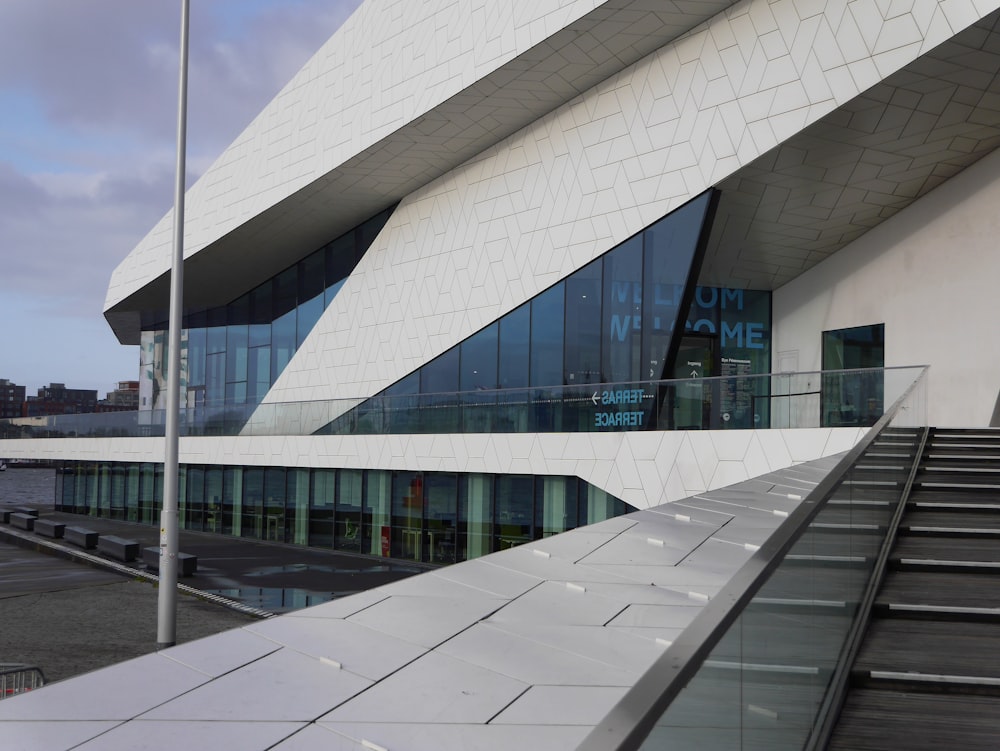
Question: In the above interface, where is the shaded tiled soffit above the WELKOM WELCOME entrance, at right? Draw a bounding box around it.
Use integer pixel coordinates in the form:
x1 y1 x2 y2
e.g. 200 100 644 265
701 11 1000 289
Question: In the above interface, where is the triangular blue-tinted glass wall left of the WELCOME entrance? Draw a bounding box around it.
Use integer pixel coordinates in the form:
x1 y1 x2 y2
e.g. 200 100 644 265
320 191 713 433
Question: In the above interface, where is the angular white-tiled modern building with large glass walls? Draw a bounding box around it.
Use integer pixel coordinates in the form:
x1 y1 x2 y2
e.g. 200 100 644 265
0 0 1000 747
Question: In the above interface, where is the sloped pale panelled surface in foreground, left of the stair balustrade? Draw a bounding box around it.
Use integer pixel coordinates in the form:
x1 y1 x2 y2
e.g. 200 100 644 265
0 458 836 751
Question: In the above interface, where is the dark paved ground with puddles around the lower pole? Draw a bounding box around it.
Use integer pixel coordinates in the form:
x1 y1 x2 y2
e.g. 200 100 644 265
0 504 423 682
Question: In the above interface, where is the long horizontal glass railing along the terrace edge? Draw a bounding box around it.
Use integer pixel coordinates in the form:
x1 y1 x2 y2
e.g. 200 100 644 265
0 366 924 440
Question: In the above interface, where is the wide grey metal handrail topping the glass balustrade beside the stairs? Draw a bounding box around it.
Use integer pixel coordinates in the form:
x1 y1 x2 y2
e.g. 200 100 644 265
578 368 926 751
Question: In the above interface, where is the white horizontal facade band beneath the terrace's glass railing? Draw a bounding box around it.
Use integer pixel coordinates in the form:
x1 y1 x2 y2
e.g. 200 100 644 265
4 428 865 509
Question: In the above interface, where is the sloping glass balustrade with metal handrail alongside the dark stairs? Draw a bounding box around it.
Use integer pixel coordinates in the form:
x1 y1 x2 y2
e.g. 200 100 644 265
579 374 926 751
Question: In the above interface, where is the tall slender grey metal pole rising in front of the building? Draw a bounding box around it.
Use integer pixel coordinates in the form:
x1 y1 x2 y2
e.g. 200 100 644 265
156 0 189 649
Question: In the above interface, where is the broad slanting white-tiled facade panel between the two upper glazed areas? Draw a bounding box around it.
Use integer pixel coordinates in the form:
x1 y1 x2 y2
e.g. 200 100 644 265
267 0 992 414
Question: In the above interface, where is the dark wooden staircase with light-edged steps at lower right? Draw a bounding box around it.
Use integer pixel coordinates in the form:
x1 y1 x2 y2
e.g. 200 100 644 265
827 429 1000 751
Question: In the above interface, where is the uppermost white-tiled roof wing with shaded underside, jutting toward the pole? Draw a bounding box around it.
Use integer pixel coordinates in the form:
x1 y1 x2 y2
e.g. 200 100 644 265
105 0 734 344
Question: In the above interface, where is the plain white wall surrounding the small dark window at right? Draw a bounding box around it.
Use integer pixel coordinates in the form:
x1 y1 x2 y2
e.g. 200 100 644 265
772 144 1000 427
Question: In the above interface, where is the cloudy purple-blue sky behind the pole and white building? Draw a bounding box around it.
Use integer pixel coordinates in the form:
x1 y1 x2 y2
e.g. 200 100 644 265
0 0 360 398
